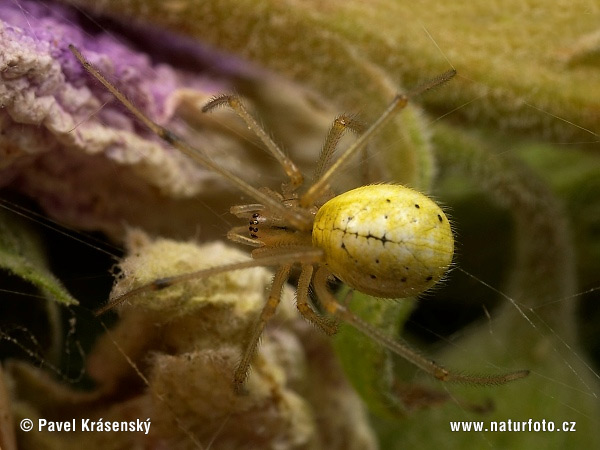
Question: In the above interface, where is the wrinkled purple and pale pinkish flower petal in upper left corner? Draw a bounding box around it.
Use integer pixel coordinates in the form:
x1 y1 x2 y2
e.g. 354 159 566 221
0 0 231 237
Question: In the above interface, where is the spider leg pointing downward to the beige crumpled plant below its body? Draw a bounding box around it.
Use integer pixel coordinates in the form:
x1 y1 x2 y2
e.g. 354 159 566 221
233 264 292 394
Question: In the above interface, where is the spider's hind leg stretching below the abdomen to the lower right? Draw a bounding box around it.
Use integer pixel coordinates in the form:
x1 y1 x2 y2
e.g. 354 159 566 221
313 267 529 385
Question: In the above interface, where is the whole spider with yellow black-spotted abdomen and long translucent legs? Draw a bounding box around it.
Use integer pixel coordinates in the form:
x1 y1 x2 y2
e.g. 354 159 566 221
69 45 529 393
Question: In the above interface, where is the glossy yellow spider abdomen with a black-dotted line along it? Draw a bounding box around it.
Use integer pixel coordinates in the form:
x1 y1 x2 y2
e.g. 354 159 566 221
312 184 454 298
